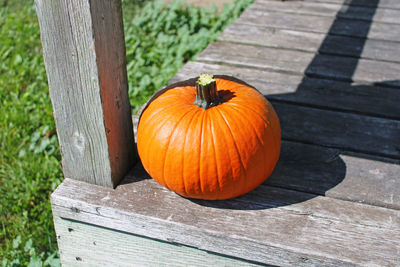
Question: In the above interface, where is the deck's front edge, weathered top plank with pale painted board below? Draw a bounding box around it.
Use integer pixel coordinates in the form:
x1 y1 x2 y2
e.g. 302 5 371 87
51 177 400 266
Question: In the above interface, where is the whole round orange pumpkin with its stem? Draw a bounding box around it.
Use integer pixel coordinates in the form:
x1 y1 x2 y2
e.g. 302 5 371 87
137 74 281 200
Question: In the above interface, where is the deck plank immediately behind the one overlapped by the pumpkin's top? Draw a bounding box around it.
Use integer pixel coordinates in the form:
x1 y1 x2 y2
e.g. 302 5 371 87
197 42 400 87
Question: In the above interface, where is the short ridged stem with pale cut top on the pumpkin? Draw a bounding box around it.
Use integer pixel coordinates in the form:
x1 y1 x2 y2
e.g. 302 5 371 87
194 74 221 109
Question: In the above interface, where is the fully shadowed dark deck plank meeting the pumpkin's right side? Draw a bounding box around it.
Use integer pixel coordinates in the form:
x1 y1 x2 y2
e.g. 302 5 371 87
273 103 400 159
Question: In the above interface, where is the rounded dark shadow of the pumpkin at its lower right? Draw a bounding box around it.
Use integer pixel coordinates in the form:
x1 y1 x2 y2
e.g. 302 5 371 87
190 141 346 210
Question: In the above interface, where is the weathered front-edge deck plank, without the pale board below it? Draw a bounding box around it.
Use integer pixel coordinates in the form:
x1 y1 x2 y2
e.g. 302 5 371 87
52 177 400 266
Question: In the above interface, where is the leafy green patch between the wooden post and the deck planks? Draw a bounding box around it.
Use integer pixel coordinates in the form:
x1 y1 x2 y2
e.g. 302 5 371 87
124 0 252 111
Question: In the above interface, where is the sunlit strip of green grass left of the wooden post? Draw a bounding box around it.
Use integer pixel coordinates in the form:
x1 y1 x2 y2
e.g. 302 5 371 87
0 1 62 266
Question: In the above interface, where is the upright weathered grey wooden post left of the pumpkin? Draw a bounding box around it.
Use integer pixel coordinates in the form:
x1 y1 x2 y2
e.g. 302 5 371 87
35 0 135 187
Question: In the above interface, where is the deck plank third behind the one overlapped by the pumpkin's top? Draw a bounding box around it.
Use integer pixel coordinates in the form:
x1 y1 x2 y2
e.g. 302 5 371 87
236 9 400 42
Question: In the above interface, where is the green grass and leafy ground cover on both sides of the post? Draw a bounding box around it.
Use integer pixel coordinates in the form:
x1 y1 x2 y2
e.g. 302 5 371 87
0 0 252 266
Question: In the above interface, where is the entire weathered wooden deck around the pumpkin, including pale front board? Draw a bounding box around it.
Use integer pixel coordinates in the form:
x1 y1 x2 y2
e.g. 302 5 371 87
52 0 400 266
